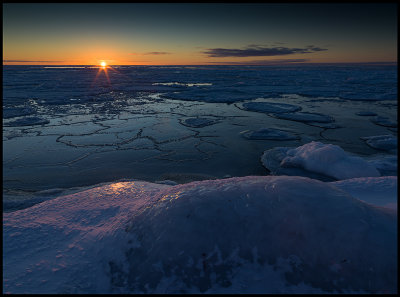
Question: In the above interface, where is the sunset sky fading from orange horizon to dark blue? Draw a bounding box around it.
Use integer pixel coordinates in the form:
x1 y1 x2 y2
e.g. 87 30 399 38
3 3 398 65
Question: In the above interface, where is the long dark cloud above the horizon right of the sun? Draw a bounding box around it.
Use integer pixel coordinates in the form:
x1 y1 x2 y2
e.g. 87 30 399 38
203 45 327 58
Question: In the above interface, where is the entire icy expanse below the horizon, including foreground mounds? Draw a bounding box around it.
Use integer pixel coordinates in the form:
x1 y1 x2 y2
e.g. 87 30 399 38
3 65 398 293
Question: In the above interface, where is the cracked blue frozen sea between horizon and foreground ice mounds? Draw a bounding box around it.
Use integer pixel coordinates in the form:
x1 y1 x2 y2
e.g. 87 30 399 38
3 65 398 211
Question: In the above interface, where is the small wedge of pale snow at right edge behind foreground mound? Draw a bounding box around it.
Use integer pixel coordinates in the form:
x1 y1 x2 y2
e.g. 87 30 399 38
331 176 397 211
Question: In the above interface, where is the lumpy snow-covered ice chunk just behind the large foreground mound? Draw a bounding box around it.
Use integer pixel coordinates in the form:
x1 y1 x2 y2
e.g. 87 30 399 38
261 141 380 180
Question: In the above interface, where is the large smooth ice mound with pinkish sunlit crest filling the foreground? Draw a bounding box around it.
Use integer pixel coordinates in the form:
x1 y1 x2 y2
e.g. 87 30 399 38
3 176 397 293
